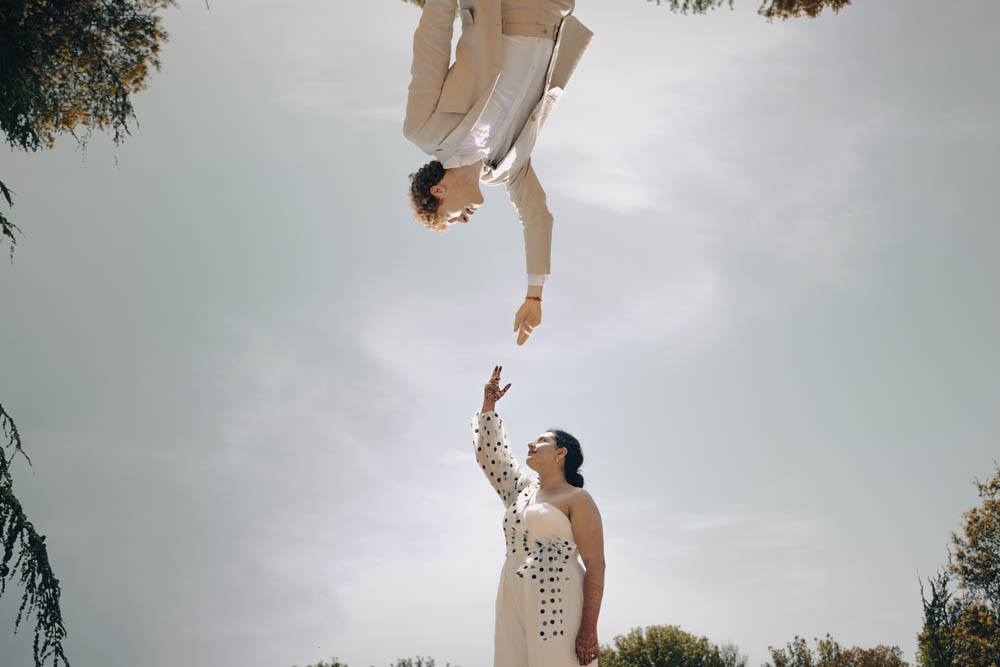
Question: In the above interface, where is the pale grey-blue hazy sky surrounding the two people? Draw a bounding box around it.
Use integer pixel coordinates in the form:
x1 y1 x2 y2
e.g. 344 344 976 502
0 0 1000 667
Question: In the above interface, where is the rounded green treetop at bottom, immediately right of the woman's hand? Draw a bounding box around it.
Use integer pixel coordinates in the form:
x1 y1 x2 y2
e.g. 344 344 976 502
598 625 747 667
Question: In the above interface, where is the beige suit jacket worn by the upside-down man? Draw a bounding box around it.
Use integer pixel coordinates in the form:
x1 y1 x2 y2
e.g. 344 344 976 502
403 0 593 274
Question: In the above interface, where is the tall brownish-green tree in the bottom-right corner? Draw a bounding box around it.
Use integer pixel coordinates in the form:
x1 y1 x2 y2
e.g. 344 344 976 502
917 465 1000 667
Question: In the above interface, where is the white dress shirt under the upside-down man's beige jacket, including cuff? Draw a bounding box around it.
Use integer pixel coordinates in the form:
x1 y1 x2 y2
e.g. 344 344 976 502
441 35 555 285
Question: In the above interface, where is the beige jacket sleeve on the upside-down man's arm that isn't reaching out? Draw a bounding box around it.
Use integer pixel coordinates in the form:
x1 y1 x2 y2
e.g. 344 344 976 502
403 0 458 138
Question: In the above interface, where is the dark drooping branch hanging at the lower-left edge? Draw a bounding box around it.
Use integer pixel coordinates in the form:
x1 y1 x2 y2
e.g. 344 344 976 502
0 405 69 667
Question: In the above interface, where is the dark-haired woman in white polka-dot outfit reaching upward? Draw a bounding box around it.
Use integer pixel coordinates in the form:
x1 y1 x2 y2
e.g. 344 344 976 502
472 366 604 667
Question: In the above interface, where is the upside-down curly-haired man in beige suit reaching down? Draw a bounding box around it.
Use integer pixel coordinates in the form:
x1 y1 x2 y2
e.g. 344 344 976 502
403 0 592 345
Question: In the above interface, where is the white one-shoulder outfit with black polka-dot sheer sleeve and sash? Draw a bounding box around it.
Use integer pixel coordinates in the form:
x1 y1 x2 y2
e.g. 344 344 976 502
472 411 597 667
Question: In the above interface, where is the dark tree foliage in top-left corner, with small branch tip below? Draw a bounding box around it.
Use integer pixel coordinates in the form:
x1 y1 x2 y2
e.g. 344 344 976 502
0 0 175 258
